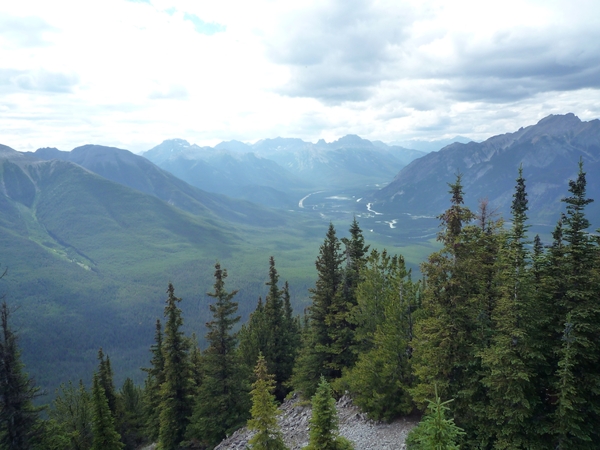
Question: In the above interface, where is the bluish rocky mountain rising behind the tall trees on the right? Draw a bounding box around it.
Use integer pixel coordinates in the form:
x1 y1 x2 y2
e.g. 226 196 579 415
372 114 600 224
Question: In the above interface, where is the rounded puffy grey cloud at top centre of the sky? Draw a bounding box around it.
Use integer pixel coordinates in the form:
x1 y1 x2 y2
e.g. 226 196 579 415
267 0 410 103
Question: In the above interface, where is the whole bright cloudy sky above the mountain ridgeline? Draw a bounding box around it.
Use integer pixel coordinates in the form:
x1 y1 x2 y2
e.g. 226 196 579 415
0 0 600 152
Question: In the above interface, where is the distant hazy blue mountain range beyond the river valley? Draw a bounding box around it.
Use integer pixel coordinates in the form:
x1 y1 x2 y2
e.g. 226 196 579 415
143 135 425 208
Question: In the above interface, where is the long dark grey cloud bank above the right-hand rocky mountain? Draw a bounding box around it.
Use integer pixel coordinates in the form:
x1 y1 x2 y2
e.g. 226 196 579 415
418 29 600 103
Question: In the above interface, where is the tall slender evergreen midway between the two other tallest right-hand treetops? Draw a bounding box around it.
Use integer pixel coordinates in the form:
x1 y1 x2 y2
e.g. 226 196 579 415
481 167 541 449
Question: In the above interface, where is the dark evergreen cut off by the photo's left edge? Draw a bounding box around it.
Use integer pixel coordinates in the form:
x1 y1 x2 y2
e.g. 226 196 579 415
0 301 42 450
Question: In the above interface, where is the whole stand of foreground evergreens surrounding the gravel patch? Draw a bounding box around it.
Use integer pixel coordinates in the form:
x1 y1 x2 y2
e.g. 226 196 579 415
0 162 600 450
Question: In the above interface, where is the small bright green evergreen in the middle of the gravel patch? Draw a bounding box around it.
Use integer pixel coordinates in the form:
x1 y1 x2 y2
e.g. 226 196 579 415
304 377 354 450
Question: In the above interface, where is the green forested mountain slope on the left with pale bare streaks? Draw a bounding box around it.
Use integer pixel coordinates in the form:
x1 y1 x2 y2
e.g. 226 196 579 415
0 143 248 387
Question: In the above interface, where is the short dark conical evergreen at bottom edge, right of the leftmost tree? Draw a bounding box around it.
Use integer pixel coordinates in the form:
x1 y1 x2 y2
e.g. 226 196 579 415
92 373 124 450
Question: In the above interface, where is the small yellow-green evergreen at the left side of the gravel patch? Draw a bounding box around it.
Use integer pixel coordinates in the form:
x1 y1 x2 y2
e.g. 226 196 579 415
248 355 286 450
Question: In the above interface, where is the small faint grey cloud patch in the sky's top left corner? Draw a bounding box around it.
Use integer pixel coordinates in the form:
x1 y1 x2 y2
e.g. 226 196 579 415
0 14 57 47
